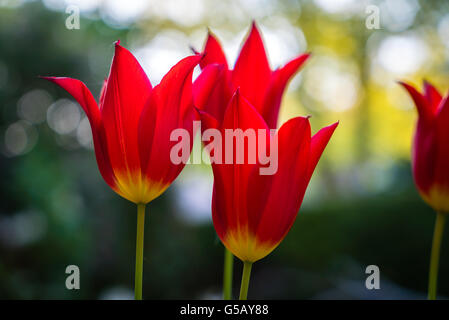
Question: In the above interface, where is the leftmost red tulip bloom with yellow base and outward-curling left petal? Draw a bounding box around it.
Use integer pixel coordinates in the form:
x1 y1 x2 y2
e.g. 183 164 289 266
44 43 201 204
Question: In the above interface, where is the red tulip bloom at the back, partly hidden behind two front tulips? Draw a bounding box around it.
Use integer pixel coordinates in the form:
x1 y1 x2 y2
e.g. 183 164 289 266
194 23 309 129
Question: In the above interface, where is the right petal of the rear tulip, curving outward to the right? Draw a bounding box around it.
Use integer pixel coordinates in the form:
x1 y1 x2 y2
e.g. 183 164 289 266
261 54 310 129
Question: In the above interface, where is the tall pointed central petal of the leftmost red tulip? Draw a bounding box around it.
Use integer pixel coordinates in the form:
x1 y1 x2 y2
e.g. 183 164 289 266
101 43 151 176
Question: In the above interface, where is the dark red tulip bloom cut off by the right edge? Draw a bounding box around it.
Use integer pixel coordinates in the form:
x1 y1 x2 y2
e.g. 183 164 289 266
401 82 449 212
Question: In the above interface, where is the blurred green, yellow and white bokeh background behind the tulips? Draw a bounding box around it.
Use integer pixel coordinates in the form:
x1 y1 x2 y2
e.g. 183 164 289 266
0 0 449 299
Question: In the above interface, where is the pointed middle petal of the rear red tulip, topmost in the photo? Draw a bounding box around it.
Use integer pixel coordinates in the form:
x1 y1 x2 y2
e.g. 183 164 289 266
232 23 271 112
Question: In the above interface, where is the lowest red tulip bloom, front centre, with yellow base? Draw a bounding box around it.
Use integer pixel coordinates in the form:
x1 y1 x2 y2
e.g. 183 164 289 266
200 90 338 262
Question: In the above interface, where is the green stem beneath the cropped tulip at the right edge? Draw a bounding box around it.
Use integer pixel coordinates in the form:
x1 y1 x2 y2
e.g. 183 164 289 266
428 212 446 300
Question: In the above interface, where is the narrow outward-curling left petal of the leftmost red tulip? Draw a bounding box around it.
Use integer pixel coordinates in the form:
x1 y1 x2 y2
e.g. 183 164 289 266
42 77 115 189
